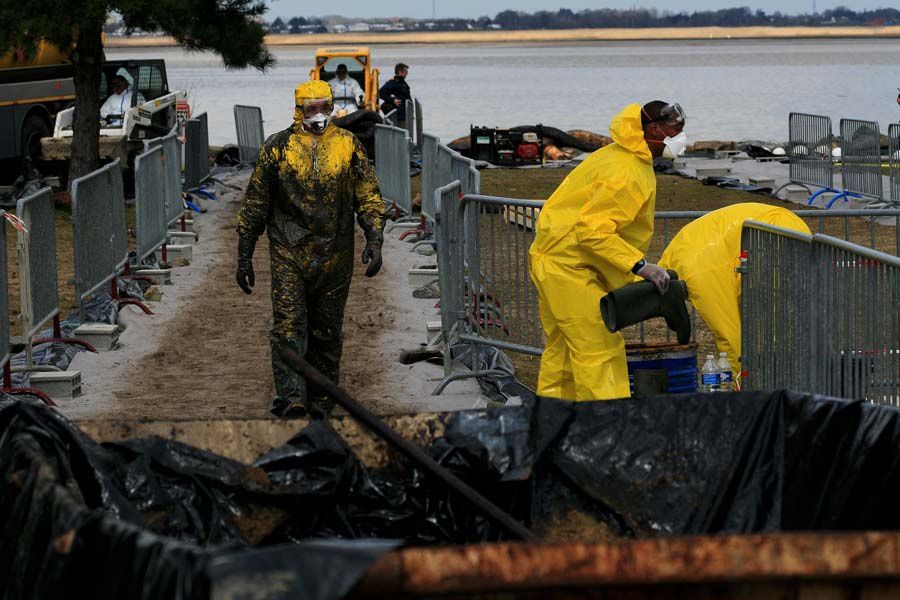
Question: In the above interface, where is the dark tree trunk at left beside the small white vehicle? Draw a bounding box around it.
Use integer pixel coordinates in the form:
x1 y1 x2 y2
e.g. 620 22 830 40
69 21 103 188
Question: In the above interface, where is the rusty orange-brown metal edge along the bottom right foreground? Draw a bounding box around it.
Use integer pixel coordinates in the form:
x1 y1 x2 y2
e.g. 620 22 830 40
354 531 900 598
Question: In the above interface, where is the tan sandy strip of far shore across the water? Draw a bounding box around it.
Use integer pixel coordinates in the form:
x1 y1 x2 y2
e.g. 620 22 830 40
106 26 900 48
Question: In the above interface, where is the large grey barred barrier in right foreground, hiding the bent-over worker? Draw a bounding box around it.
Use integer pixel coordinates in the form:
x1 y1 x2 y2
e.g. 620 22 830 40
742 223 900 406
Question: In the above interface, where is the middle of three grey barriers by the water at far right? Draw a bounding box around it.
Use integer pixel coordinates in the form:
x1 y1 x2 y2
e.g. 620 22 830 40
829 119 884 205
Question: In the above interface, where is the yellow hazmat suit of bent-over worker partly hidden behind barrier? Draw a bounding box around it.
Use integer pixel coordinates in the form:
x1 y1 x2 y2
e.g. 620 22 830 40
659 202 810 373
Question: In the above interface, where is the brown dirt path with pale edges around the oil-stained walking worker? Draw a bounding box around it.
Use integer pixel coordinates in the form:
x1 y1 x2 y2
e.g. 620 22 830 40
62 172 479 419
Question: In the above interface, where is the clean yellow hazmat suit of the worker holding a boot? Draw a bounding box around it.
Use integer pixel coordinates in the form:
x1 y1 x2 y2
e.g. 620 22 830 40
529 104 656 400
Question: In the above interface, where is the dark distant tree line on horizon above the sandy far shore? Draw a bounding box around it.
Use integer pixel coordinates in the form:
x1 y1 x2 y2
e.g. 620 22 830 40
253 6 900 33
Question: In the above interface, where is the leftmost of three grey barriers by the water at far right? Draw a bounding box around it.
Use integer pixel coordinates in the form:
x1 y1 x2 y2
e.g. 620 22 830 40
788 113 834 191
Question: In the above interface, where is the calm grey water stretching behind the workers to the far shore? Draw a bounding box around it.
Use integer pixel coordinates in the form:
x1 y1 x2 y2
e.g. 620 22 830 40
108 40 900 145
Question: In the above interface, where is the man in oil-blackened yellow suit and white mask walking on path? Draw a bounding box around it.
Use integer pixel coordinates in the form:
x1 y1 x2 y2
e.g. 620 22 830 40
237 80 384 417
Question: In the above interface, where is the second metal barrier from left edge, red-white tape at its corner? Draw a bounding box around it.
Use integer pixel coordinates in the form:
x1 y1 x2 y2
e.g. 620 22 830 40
16 188 59 344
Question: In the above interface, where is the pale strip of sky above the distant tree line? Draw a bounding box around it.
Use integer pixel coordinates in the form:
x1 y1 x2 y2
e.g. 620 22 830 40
267 0 896 18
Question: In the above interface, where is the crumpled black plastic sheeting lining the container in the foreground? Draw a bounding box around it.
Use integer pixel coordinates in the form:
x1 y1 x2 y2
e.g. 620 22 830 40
0 392 900 600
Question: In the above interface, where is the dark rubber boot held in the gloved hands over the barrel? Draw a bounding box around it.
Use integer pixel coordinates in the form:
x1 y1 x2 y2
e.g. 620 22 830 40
600 271 691 344
